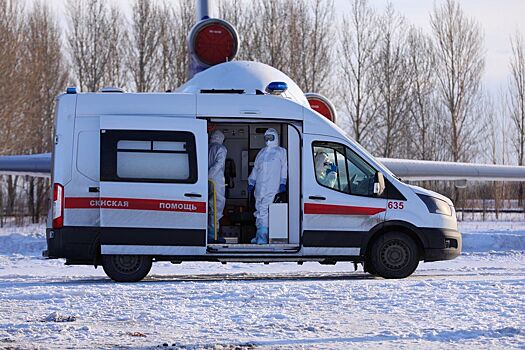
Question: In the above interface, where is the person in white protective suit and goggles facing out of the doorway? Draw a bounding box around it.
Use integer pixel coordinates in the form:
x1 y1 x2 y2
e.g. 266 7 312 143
248 128 288 244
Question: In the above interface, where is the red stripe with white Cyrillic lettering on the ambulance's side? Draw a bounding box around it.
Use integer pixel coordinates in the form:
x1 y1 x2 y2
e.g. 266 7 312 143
65 197 207 213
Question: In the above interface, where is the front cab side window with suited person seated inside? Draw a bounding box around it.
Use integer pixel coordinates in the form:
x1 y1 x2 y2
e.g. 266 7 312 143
312 141 375 196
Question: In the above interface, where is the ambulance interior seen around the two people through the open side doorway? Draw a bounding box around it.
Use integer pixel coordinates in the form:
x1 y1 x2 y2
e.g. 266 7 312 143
208 120 300 248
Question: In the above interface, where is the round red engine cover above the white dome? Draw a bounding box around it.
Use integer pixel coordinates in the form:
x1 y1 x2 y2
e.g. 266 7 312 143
189 18 239 66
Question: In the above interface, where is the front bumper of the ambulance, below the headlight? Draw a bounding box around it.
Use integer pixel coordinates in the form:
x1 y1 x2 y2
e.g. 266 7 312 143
421 228 462 261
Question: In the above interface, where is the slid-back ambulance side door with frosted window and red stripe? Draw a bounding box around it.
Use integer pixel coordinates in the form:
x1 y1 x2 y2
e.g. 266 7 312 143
98 116 208 256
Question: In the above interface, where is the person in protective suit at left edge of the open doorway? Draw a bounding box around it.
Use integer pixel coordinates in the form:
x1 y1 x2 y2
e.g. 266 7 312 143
208 130 228 243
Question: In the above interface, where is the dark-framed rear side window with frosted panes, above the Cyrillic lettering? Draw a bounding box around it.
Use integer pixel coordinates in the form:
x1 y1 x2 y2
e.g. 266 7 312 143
100 130 197 183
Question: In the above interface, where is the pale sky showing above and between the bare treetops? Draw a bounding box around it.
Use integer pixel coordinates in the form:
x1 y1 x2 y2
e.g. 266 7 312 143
47 0 525 93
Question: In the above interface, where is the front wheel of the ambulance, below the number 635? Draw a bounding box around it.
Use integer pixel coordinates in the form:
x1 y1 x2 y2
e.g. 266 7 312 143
370 232 419 278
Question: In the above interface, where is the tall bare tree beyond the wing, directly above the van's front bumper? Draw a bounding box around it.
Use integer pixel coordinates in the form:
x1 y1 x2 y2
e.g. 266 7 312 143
430 0 484 162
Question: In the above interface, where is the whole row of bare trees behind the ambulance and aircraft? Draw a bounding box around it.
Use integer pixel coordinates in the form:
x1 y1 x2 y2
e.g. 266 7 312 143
0 0 525 222
